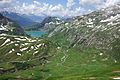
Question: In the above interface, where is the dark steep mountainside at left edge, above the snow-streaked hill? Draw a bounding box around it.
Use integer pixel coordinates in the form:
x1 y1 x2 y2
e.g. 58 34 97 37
0 14 25 35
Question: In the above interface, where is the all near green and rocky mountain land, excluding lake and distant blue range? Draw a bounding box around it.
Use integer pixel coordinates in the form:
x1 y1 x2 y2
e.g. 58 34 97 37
0 5 120 80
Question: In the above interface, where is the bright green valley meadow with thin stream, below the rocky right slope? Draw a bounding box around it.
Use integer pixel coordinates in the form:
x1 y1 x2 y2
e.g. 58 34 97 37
42 31 120 80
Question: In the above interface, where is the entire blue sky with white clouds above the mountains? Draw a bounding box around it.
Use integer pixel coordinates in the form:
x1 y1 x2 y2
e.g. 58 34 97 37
0 0 120 17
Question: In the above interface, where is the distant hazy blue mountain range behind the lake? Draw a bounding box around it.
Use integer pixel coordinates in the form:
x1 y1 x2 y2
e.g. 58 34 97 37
0 11 44 27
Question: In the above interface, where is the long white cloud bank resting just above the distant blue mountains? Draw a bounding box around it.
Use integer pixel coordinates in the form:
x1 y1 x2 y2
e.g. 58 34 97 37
2 0 82 17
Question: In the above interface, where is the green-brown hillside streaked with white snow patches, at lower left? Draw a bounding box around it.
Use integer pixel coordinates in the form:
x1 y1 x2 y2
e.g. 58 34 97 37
0 35 56 80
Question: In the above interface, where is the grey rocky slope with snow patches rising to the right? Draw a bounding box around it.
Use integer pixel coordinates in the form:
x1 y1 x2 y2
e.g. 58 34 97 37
47 5 120 60
